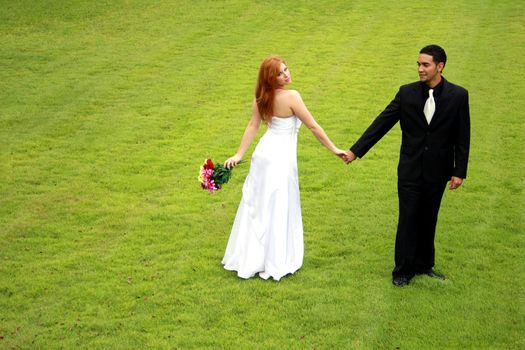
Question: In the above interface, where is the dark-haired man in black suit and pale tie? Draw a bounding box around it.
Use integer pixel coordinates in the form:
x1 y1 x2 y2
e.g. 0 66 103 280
345 45 470 287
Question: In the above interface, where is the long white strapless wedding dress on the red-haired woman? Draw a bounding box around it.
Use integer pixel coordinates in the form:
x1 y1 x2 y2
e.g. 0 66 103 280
222 116 304 281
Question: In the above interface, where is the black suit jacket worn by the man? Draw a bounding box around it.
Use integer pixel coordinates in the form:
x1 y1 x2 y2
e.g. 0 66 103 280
350 78 470 182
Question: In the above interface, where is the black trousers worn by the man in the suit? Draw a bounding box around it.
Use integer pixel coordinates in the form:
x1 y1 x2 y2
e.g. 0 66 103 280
392 179 447 277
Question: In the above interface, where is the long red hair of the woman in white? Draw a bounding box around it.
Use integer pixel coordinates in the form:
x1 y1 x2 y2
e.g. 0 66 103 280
255 56 286 123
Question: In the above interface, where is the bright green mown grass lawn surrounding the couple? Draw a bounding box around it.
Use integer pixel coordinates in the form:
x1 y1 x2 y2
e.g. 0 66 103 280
0 0 525 349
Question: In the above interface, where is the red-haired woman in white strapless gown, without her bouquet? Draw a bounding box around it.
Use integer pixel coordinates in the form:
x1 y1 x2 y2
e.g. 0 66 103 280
222 56 345 281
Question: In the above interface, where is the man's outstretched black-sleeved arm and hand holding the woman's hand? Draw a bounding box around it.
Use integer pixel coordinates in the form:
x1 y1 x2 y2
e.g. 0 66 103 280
346 90 401 158
